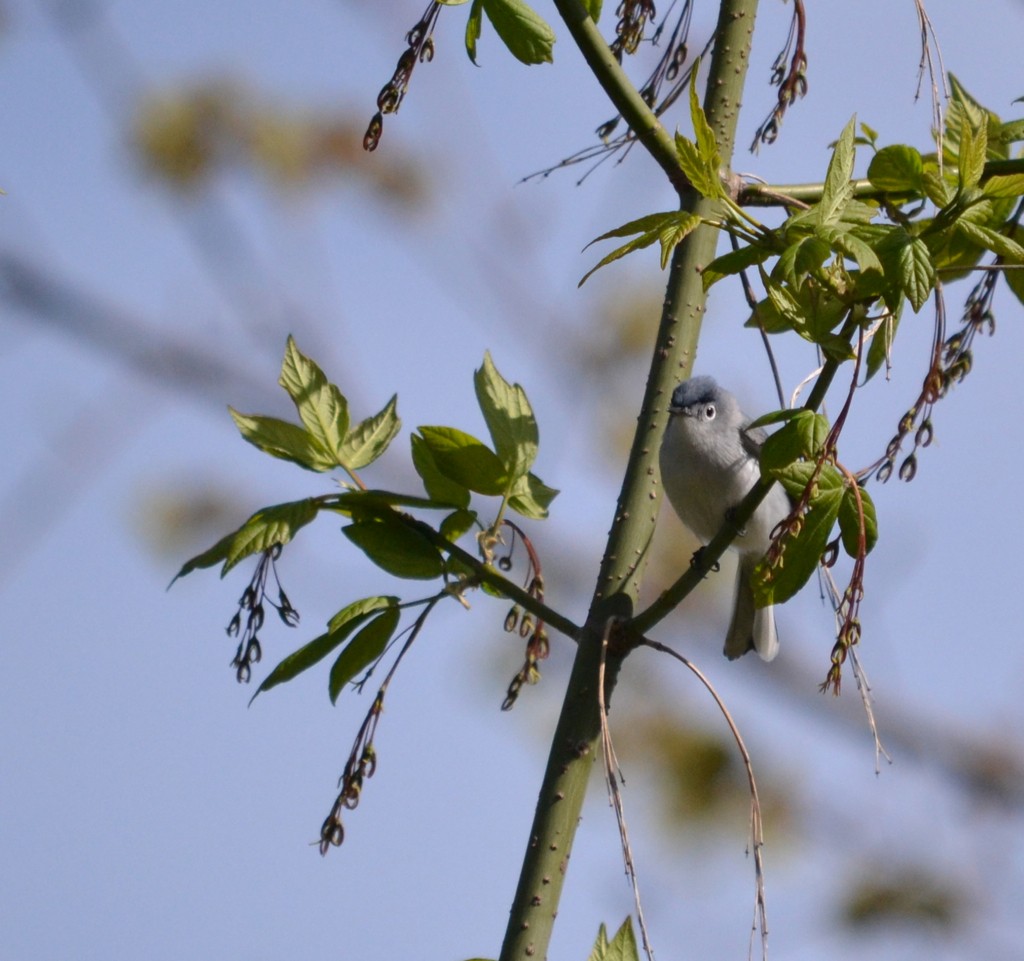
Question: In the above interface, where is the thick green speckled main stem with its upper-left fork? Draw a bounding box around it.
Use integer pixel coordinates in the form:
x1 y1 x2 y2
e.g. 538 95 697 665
501 0 757 961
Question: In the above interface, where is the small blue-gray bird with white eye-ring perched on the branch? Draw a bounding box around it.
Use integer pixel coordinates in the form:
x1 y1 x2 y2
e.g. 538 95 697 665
660 377 791 661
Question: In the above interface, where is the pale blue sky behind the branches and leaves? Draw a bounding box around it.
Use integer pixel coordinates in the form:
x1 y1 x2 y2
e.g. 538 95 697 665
0 0 1024 961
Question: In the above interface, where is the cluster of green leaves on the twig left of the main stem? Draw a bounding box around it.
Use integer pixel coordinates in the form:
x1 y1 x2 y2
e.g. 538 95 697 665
177 337 558 701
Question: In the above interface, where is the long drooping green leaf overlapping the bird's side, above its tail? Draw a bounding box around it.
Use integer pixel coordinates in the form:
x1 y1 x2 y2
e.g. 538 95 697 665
754 461 844 608
